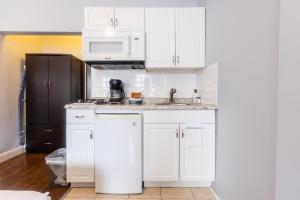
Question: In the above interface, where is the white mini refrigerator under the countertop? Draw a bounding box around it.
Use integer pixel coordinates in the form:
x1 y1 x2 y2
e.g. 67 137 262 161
95 114 142 194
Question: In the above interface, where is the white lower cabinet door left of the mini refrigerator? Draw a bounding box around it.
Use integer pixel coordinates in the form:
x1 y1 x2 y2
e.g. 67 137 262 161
67 125 94 182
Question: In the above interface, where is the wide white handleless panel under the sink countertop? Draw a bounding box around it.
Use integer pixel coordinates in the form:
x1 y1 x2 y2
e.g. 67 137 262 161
144 110 215 124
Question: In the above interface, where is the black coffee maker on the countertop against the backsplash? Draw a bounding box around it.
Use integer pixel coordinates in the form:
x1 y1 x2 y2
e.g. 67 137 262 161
109 79 125 103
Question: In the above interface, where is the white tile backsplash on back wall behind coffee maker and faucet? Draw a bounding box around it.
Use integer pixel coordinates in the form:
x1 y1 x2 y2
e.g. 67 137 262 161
91 68 197 98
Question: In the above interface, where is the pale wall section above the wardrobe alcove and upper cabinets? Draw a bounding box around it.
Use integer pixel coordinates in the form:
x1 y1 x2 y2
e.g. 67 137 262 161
0 0 205 32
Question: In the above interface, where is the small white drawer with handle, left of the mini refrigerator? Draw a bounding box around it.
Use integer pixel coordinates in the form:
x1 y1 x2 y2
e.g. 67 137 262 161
67 109 95 124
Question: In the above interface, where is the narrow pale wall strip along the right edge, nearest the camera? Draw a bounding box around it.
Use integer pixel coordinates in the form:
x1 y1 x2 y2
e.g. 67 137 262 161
276 0 300 200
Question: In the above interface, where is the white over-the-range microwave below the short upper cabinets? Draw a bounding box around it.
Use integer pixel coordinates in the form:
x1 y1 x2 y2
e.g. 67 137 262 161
82 29 145 61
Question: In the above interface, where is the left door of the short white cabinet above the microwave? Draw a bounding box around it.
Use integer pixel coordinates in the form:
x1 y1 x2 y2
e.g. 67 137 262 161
84 7 114 29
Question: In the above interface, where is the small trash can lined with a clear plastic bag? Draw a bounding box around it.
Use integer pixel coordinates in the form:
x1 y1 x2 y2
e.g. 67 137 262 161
45 148 68 186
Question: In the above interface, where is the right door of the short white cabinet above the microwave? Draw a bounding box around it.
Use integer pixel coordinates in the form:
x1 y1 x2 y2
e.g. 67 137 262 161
115 8 144 31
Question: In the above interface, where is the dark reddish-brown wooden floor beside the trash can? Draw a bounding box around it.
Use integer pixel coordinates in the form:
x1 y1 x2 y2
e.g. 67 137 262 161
0 154 68 200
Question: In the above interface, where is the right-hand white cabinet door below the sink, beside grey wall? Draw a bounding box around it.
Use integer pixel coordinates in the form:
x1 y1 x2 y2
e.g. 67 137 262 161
180 124 215 181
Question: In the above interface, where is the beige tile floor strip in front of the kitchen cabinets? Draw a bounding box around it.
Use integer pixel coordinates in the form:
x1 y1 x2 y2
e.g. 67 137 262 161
64 188 216 200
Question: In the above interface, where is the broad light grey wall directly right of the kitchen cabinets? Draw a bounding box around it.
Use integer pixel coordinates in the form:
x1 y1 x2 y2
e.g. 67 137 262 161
207 0 278 200
